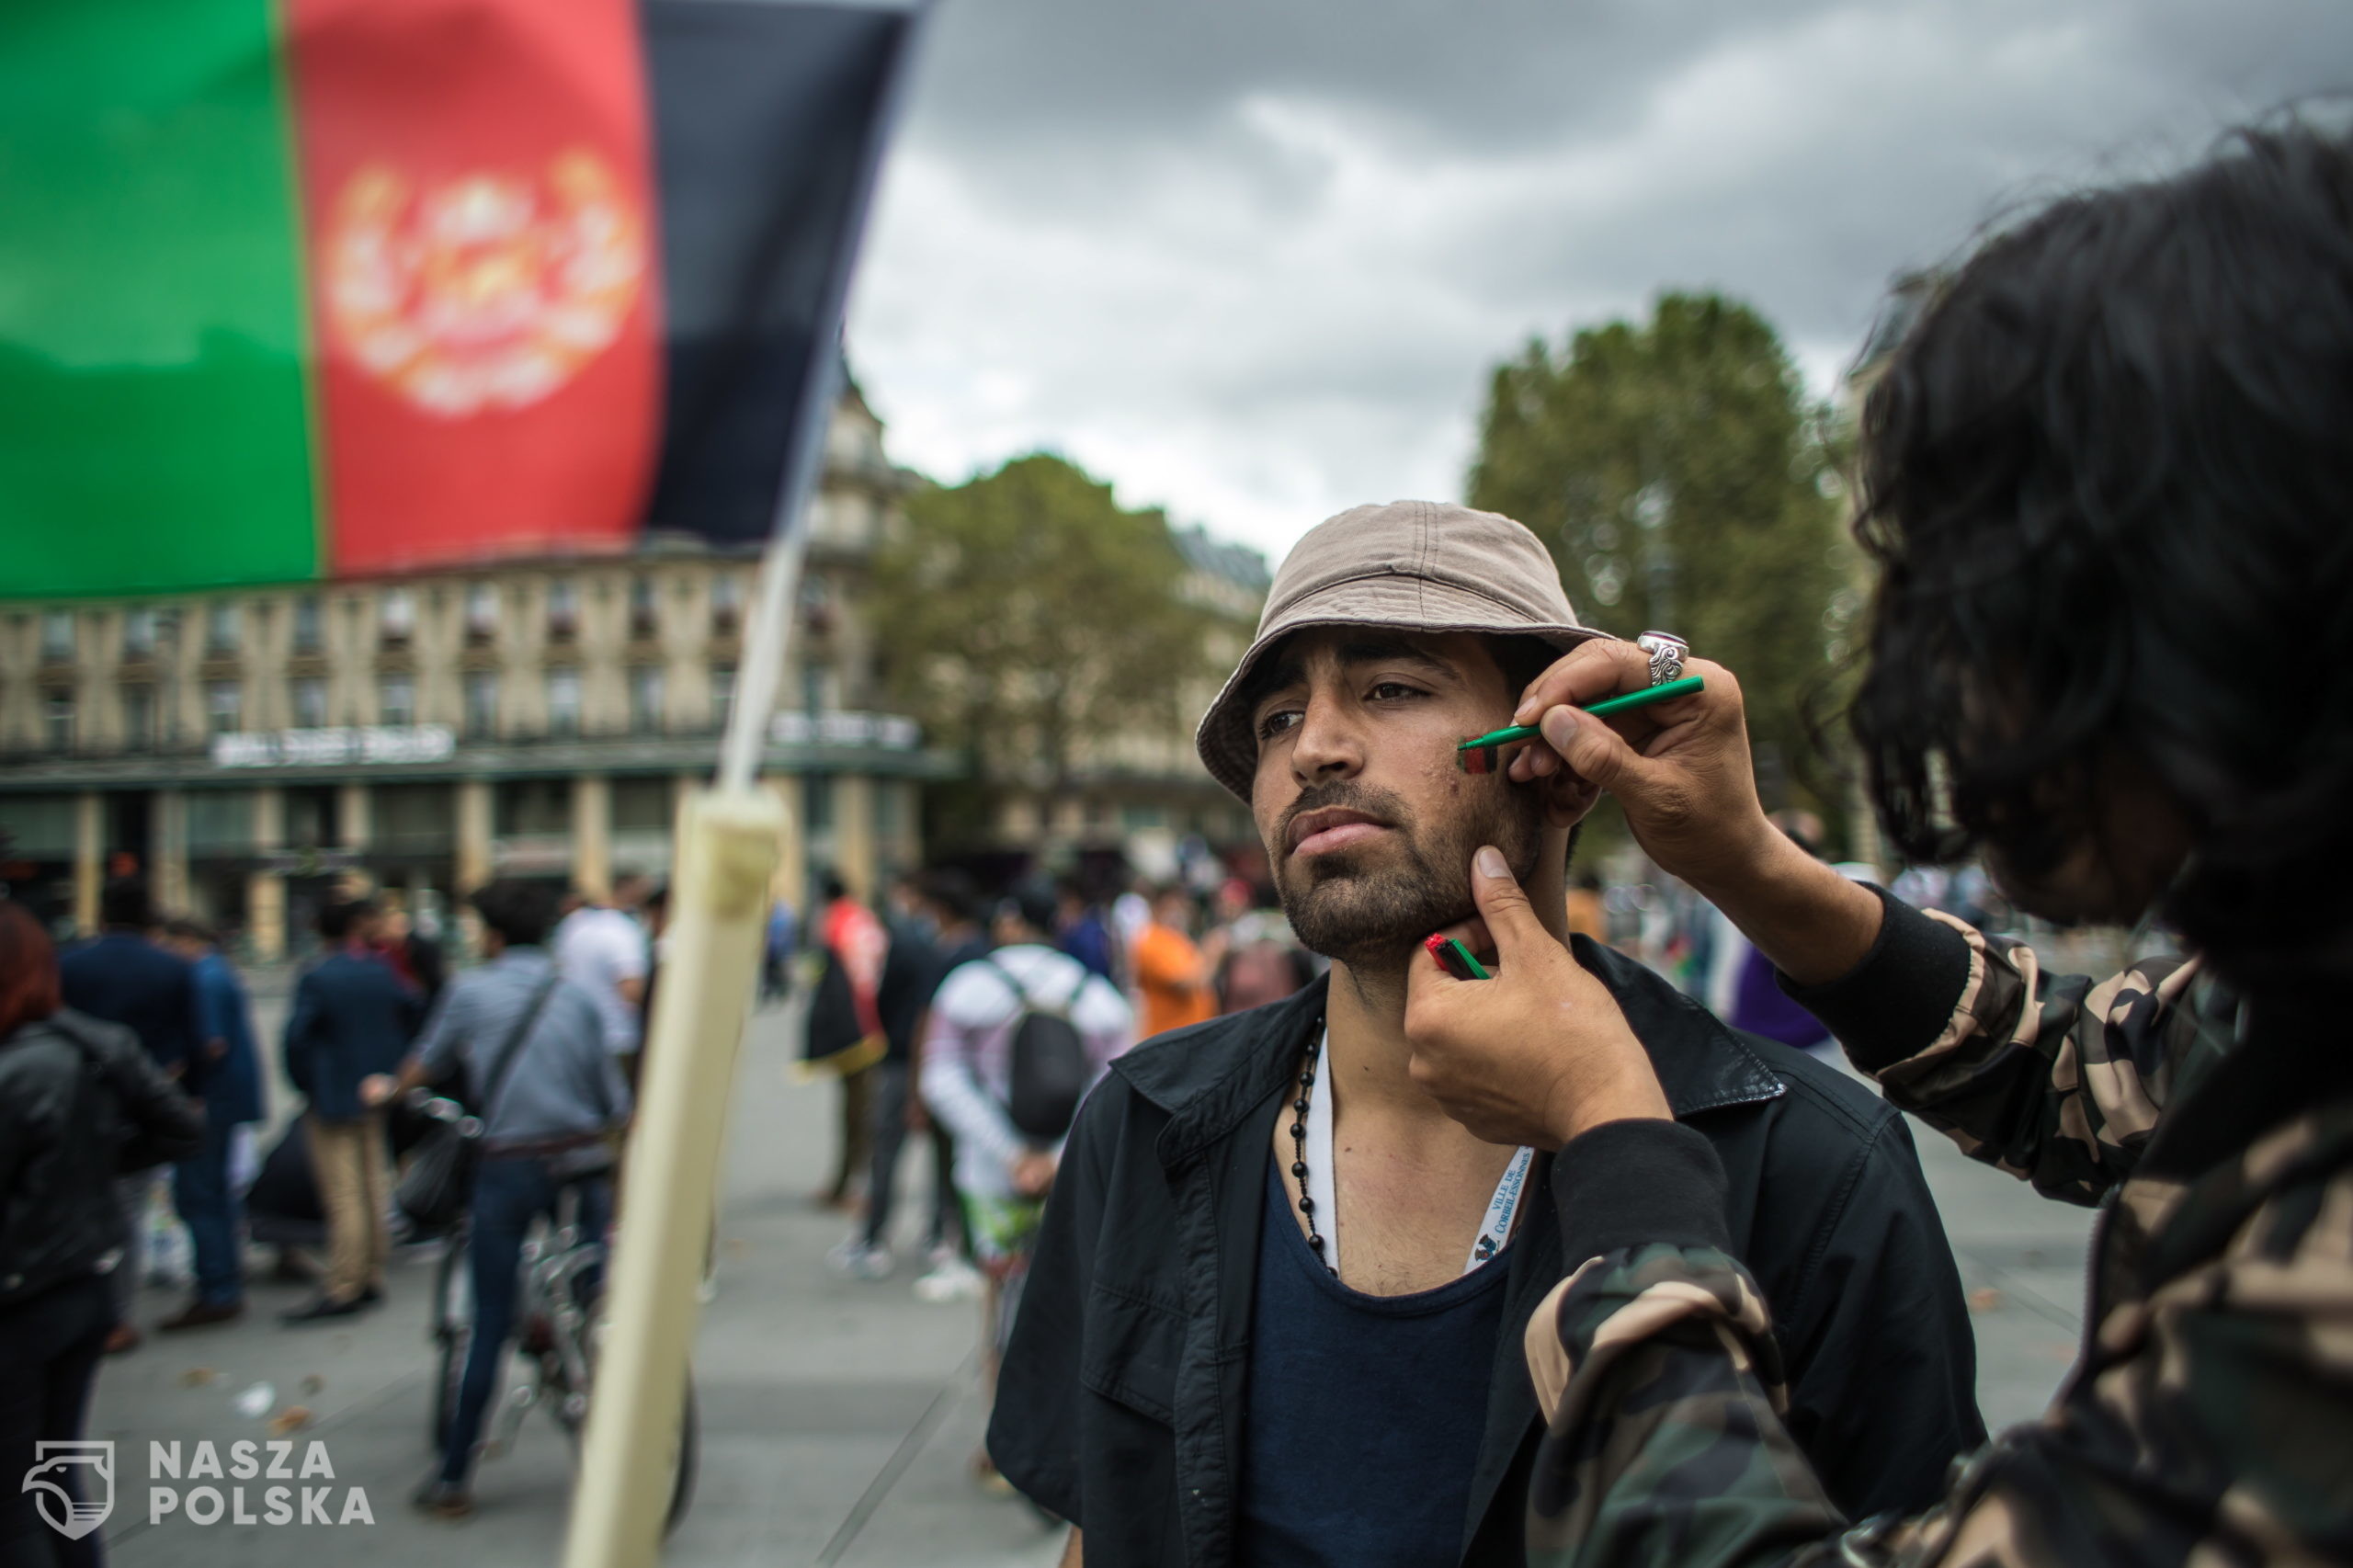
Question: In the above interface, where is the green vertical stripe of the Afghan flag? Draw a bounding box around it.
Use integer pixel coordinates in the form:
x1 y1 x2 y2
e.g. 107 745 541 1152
0 0 320 598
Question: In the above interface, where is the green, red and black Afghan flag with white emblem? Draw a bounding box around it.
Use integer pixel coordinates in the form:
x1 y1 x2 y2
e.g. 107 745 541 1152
0 0 913 598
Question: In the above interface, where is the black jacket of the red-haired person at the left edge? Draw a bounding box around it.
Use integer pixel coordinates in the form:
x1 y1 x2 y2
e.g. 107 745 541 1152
0 1012 205 1307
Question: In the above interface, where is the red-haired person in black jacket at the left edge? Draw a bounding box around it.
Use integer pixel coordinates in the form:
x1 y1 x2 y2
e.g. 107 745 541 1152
0 902 205 1568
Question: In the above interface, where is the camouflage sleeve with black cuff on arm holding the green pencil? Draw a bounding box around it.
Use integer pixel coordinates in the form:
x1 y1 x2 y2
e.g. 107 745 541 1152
1789 900 2219 1203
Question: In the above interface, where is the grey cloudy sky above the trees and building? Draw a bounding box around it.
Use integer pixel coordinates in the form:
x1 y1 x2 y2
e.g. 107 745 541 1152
849 0 2353 556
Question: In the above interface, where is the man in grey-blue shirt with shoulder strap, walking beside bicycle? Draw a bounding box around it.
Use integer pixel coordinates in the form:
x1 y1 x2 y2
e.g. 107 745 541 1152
365 878 631 1518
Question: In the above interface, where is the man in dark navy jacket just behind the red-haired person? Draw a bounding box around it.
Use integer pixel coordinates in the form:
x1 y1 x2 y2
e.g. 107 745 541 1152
59 876 205 1356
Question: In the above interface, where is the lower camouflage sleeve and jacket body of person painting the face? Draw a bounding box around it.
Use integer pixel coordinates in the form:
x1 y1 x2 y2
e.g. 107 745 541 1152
1527 1096 2353 1568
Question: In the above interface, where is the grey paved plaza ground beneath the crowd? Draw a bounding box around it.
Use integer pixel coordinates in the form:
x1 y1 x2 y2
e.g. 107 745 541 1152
89 998 2089 1568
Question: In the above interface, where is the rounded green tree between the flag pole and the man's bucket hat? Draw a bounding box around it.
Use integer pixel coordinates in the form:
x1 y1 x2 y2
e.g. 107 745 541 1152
875 452 1205 840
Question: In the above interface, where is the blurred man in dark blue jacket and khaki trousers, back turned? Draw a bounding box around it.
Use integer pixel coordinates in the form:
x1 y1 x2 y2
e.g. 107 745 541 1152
285 900 421 1324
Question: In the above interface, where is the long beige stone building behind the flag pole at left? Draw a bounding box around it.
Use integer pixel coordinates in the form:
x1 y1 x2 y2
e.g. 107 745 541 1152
0 389 944 959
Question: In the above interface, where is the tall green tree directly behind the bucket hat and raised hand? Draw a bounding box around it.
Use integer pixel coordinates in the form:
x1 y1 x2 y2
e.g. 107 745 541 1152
1471 294 1857 814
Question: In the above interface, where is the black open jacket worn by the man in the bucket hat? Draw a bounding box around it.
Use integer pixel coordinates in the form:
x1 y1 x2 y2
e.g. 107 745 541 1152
988 937 1984 1568
